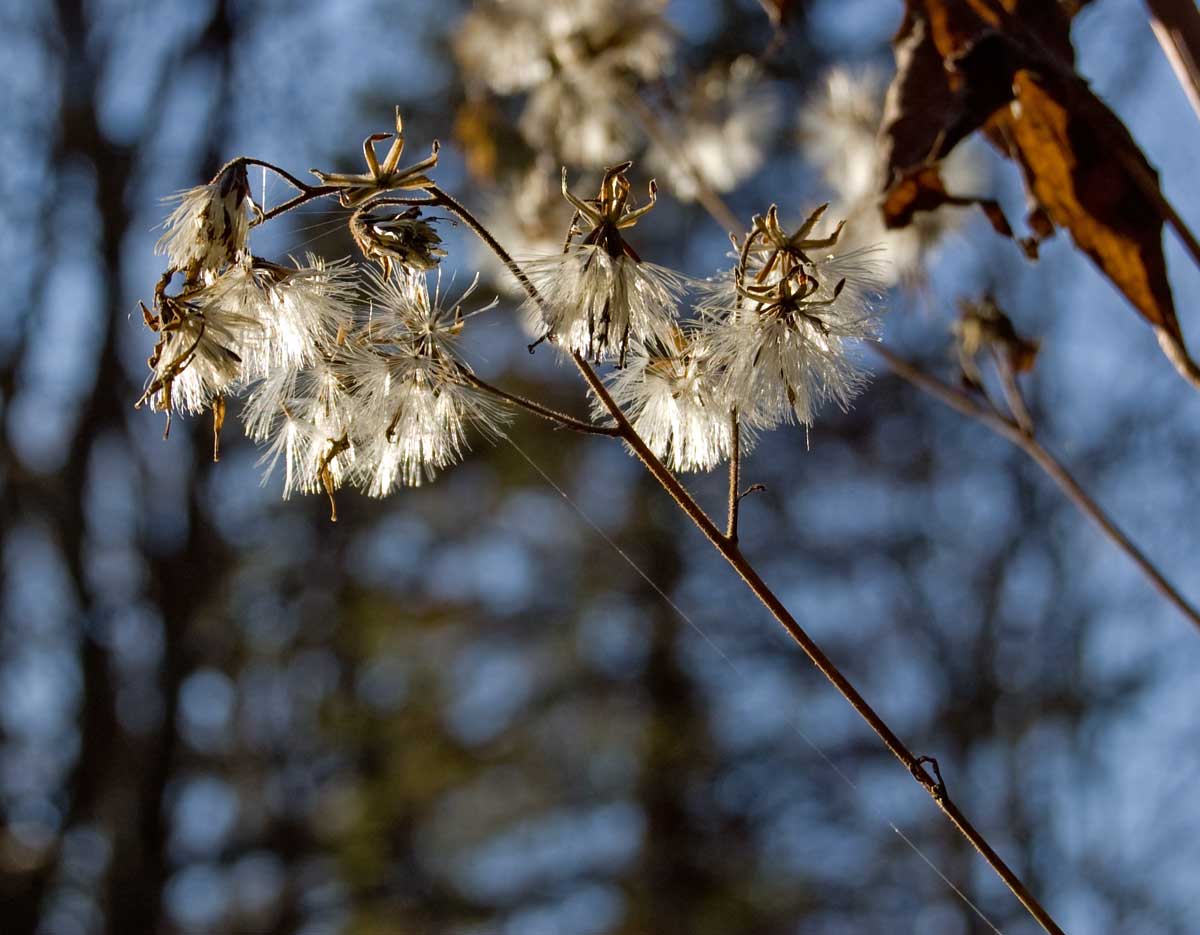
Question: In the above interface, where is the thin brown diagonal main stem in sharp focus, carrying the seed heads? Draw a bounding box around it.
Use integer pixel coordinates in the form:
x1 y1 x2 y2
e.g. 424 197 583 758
426 186 1062 935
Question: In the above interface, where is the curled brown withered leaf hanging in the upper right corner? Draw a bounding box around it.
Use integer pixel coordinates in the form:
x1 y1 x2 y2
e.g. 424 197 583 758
883 0 1182 340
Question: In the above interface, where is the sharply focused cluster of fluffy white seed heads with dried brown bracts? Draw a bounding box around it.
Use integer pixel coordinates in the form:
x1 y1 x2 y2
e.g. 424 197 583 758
139 111 877 519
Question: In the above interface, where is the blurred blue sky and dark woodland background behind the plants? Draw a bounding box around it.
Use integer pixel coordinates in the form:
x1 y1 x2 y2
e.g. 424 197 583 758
0 0 1200 935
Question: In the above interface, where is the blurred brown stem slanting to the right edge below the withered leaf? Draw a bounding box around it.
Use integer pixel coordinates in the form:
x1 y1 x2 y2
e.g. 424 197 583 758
875 344 1200 628
